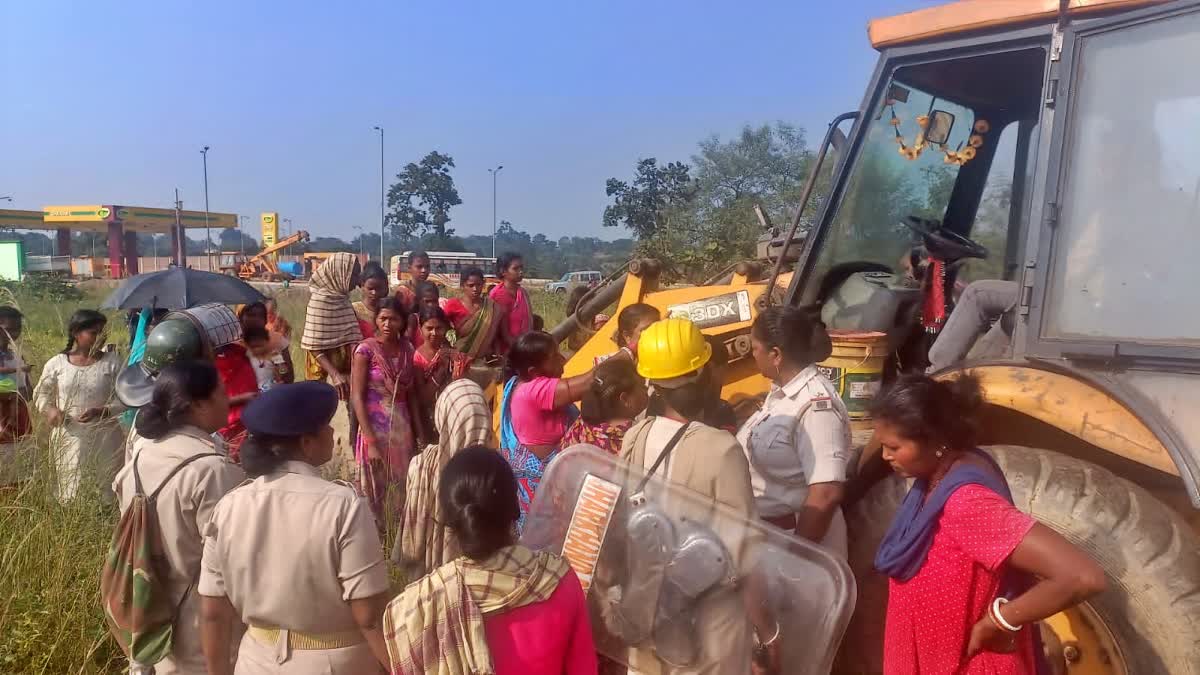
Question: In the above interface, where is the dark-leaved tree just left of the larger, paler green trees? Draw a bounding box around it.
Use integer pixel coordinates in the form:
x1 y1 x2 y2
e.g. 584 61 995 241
604 157 696 243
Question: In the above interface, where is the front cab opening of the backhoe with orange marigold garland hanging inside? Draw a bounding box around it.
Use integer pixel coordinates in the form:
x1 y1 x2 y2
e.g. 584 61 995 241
806 47 1046 297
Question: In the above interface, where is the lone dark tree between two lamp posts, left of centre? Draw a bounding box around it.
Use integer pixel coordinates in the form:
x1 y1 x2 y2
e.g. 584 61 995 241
386 150 462 247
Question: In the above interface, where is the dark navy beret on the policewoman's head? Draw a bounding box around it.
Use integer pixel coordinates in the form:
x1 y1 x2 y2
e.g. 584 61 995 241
241 381 337 436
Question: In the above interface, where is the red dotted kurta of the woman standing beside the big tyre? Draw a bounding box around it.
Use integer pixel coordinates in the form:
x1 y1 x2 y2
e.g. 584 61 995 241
883 485 1034 675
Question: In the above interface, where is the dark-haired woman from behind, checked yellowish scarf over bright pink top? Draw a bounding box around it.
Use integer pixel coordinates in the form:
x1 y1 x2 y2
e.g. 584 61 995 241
384 447 596 675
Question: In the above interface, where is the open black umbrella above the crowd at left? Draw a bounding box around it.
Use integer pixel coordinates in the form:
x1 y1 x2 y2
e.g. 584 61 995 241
102 267 264 310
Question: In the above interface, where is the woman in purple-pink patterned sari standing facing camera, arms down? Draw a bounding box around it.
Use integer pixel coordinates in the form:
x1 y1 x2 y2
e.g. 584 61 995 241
350 298 425 527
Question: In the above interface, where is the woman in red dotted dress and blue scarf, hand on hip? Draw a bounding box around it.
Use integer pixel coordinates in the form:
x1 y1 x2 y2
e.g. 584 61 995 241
874 375 1106 675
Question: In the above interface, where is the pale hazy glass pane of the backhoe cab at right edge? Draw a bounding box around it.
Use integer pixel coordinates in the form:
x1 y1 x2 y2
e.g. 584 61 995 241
1042 13 1200 345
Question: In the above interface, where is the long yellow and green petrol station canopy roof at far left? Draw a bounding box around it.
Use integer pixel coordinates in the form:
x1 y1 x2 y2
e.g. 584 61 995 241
0 204 238 233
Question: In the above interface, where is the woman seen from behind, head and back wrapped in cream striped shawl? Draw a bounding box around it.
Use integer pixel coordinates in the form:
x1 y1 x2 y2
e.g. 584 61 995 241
391 380 492 579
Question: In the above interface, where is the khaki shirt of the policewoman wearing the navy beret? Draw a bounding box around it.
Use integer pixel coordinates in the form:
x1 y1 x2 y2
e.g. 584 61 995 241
199 461 389 633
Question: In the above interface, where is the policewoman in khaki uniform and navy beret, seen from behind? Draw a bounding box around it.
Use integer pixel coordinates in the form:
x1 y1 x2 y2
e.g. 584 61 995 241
199 382 389 675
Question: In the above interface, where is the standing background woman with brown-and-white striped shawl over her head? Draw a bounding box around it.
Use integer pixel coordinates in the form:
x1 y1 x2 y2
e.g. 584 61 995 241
300 252 362 401
